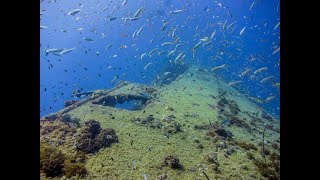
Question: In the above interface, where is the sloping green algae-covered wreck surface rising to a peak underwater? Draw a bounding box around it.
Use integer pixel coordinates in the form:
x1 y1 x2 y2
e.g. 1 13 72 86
40 66 280 180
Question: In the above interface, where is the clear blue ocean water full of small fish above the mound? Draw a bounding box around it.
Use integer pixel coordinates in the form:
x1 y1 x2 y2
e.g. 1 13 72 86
40 0 280 116
